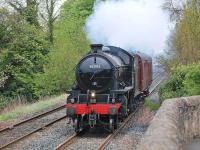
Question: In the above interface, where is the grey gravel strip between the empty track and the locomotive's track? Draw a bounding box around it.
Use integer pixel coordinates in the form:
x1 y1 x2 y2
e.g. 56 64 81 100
5 119 74 150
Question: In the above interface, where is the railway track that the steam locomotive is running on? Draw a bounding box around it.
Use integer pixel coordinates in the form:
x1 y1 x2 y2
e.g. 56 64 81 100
55 73 164 150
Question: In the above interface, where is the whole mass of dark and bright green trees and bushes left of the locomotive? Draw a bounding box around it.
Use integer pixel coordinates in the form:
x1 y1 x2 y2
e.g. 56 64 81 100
0 0 95 111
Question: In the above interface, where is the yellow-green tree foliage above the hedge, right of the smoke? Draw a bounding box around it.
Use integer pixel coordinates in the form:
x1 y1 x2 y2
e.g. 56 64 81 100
173 0 200 65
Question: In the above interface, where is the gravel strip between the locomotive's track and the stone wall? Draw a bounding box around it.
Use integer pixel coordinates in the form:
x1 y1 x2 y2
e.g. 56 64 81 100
106 107 154 150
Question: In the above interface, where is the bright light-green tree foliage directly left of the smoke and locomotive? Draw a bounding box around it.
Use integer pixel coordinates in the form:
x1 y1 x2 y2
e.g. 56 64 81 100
33 0 94 96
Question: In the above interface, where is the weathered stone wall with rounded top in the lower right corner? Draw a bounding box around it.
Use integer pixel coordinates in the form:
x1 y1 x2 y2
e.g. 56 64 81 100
138 96 200 150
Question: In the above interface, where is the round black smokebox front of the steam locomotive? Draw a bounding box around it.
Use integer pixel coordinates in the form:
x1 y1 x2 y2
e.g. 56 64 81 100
76 50 113 92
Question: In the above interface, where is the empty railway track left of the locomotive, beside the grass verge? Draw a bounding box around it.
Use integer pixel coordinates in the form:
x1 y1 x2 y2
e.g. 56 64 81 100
0 105 66 149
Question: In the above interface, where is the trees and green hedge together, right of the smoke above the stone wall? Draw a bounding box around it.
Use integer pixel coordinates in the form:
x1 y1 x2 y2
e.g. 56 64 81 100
159 0 200 101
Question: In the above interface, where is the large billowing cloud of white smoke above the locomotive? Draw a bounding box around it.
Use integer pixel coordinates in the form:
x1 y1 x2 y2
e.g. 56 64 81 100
85 0 170 56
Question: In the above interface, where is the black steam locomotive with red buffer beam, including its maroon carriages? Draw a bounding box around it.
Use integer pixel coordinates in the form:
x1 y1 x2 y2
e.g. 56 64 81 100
65 44 152 132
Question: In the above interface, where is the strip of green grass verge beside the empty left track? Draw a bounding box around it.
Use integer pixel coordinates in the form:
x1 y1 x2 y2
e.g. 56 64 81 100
0 94 67 121
